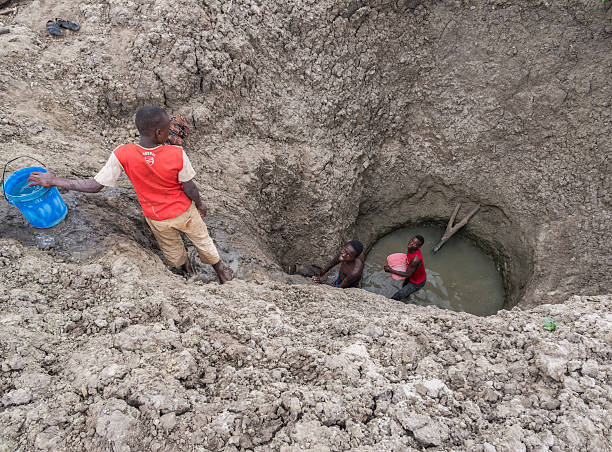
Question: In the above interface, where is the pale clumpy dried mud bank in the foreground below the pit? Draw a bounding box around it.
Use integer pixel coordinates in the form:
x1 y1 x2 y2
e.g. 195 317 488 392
0 239 612 451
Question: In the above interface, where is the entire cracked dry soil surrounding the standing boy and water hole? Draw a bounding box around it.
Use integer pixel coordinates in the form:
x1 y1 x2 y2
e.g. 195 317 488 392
0 0 612 451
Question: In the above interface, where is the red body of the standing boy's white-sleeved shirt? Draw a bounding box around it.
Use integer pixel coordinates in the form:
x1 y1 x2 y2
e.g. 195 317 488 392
115 144 191 221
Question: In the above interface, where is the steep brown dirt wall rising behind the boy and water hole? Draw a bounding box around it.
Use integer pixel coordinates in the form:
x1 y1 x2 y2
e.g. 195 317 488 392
1 0 612 303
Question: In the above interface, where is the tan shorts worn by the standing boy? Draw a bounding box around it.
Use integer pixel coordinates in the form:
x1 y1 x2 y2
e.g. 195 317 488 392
145 203 219 267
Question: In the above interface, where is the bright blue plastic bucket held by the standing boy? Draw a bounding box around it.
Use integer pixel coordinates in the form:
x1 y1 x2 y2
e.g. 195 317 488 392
2 157 68 228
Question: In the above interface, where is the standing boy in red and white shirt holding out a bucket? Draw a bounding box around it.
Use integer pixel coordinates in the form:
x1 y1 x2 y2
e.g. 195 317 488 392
29 106 233 284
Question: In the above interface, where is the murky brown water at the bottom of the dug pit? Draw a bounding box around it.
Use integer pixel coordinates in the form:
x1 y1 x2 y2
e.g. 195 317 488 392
361 227 504 316
